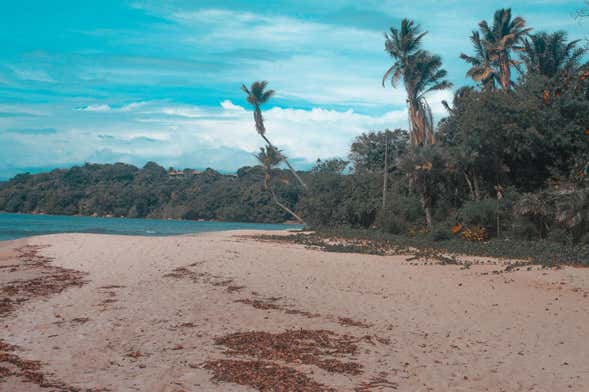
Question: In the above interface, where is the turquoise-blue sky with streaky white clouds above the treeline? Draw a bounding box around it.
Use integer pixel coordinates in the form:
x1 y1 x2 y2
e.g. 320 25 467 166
0 0 589 179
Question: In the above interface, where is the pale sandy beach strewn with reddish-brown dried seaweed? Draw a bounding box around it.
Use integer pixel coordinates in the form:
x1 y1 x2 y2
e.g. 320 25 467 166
0 232 589 391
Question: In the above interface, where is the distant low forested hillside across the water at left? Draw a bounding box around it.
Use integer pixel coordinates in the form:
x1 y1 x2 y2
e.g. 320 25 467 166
0 162 298 222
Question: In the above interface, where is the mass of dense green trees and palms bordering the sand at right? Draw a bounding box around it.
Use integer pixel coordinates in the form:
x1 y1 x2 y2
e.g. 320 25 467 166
301 10 589 254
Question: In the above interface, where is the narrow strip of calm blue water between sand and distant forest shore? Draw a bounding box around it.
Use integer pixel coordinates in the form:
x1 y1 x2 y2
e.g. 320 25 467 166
0 212 301 241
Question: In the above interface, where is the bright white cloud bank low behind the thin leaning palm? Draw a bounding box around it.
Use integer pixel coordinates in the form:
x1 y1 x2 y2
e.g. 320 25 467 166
121 100 418 163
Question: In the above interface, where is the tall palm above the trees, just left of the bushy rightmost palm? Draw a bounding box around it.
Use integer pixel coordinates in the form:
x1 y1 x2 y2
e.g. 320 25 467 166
479 8 532 91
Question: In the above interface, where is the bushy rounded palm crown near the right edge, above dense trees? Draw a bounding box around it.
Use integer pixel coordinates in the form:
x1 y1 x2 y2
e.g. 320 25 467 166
521 31 587 78
